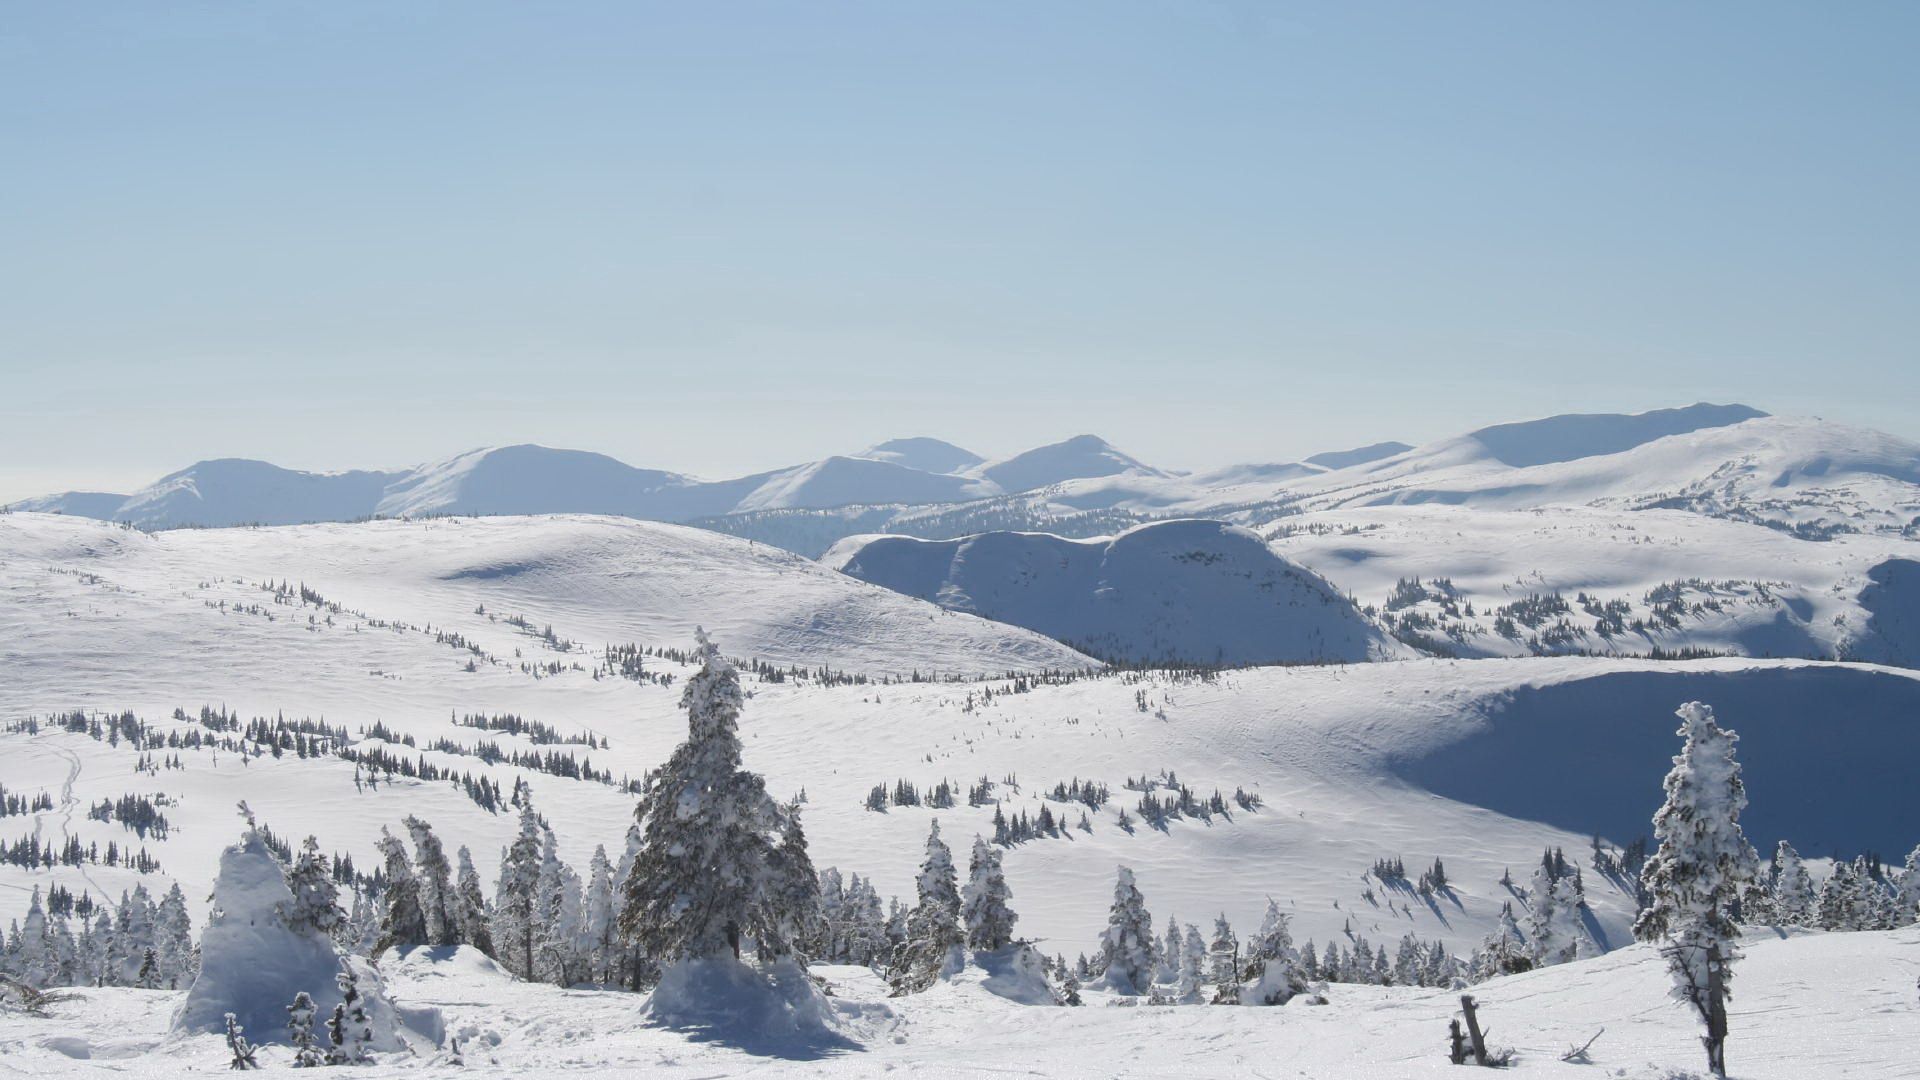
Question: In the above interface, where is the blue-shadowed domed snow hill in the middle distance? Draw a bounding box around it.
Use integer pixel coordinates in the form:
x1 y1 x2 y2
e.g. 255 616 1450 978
824 521 1411 665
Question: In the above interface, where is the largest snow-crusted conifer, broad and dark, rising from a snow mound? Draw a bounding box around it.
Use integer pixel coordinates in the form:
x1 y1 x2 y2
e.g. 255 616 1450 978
620 632 791 965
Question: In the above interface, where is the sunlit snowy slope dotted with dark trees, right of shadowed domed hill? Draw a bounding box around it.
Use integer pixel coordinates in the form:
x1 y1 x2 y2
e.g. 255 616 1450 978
1265 503 1920 667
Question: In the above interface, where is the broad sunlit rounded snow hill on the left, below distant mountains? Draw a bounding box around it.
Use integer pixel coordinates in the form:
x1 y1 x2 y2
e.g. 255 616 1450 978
0 513 1091 675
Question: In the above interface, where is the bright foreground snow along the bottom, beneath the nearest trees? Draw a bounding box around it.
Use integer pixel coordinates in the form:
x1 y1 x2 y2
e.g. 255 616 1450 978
0 928 1920 1080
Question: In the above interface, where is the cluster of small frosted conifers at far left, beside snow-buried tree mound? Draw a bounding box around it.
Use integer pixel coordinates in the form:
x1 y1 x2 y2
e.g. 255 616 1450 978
0 886 200 990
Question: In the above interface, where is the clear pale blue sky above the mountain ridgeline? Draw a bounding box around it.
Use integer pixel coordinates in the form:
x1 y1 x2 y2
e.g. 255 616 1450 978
0 0 1920 498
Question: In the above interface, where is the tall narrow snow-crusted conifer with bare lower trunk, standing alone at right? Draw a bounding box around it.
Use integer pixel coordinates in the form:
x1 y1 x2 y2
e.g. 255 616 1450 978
1634 701 1757 1076
